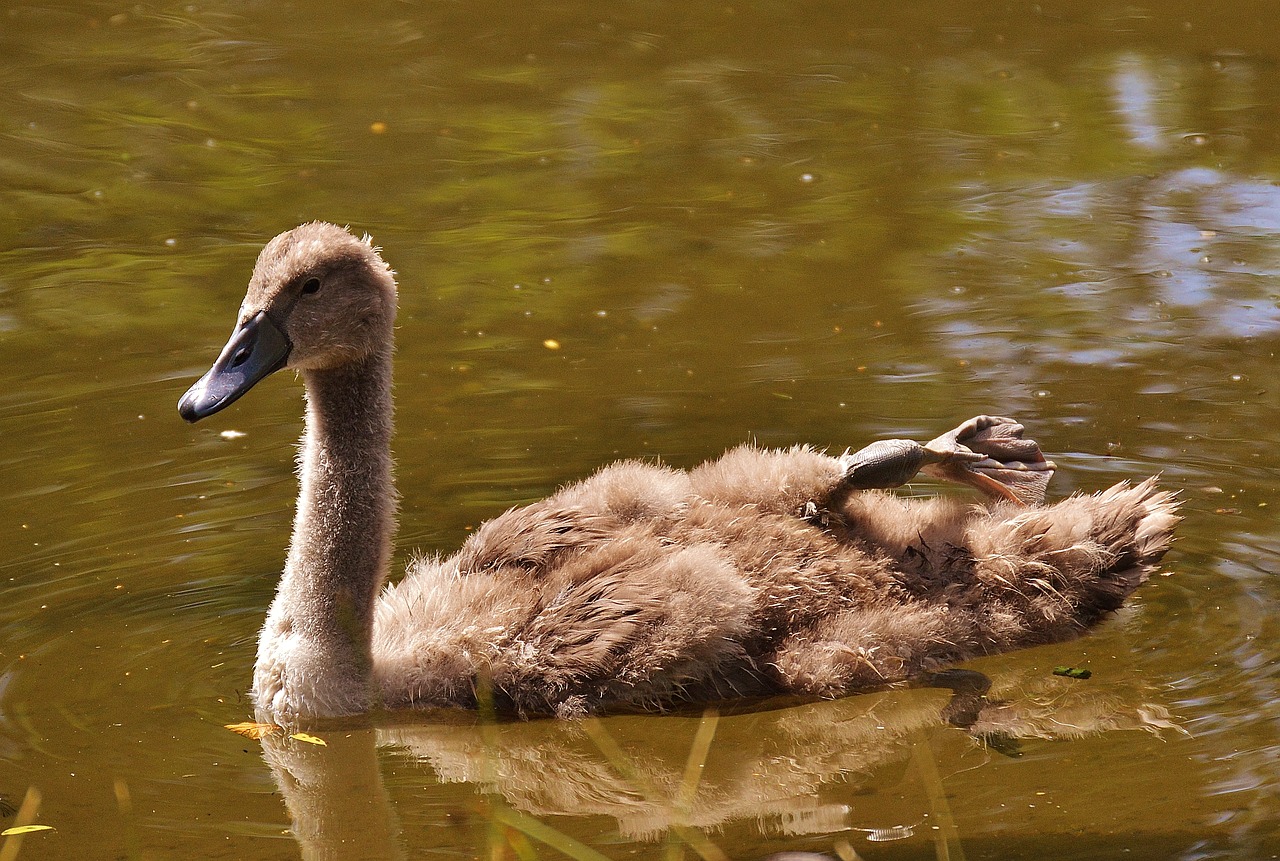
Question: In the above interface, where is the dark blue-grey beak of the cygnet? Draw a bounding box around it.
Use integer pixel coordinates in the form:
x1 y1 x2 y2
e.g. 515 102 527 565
178 311 293 422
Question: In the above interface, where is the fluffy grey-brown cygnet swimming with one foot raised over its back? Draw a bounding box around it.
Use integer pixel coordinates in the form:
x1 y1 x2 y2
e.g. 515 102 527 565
178 223 1178 719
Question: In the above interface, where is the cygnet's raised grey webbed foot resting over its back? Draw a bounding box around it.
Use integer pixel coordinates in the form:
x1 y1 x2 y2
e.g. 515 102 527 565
841 416 1055 505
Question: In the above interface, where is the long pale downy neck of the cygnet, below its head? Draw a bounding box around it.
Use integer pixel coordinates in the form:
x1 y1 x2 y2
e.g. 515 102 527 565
255 349 394 715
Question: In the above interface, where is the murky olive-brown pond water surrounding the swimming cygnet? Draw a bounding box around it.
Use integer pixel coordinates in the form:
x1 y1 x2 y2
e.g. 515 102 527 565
0 0 1280 861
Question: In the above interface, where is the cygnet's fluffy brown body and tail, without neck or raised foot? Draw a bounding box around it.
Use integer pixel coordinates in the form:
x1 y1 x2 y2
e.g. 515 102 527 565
375 446 1176 714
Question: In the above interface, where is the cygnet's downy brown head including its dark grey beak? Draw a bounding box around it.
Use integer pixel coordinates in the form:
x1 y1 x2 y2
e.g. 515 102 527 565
178 221 396 422
